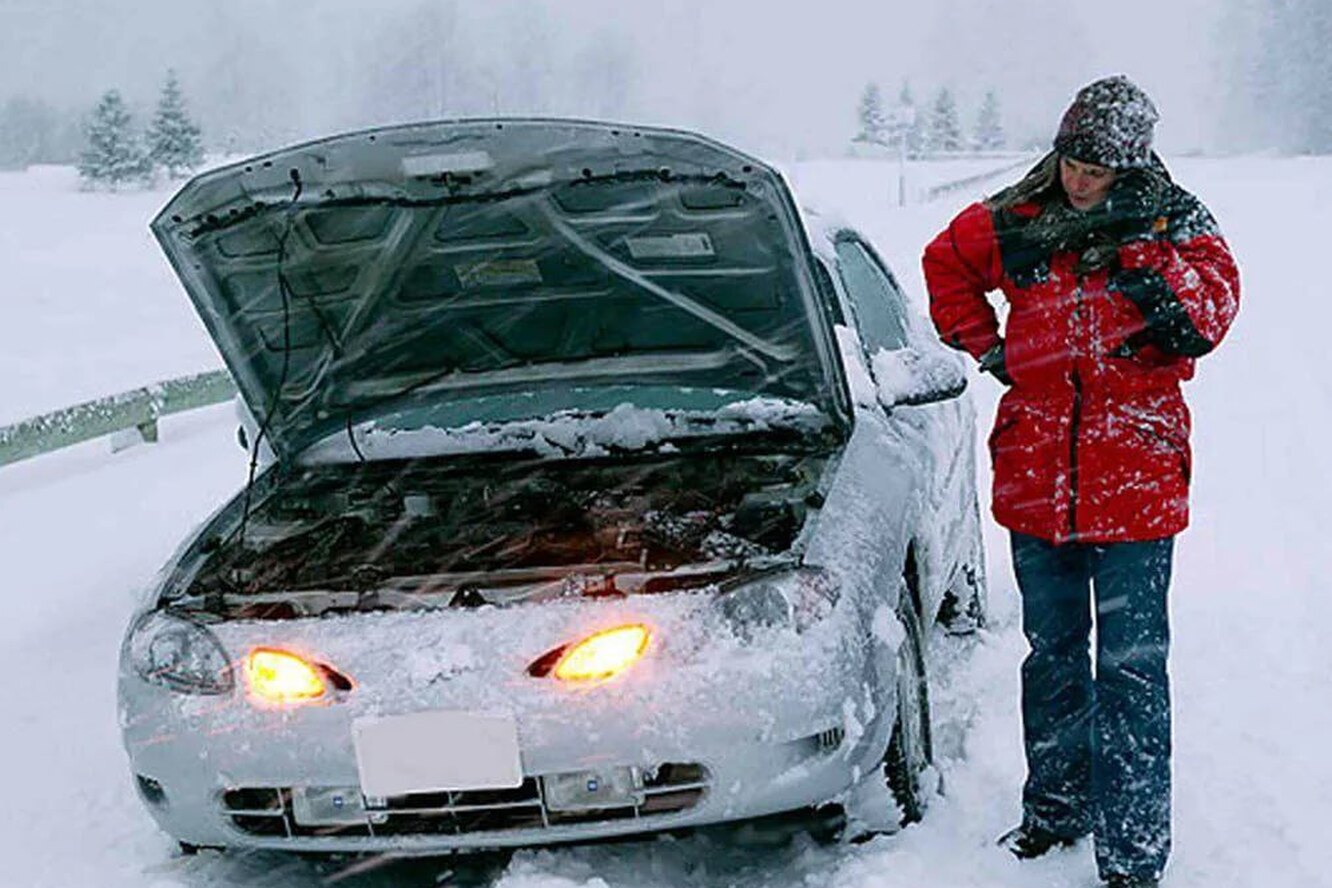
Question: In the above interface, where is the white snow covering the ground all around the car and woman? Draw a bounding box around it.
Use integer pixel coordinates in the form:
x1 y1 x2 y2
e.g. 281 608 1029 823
0 158 1332 888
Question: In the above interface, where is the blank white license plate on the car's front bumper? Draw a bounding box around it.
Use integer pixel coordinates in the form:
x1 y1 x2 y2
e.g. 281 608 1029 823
352 710 522 797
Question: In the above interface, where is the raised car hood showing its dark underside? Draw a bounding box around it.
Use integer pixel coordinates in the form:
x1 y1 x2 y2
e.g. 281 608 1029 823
152 120 846 459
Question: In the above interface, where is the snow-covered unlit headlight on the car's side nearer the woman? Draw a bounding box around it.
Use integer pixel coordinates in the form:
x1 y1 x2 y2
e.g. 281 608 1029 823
717 567 838 638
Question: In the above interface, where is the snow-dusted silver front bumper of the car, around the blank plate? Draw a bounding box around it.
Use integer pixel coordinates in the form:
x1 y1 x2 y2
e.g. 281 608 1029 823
120 607 894 853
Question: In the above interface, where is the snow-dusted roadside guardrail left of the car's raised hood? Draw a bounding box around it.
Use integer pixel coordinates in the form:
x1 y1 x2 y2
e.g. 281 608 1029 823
0 370 236 466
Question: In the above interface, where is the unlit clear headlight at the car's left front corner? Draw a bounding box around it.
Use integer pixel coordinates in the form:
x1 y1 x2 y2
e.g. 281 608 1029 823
129 611 234 694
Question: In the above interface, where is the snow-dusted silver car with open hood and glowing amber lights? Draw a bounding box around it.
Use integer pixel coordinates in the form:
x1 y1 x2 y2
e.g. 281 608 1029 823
119 120 984 855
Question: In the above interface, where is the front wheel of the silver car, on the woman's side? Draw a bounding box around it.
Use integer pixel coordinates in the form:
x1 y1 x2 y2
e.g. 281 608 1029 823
883 595 934 825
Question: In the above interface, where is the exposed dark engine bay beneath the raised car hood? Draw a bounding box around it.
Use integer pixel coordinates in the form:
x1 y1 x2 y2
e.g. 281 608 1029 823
186 451 829 618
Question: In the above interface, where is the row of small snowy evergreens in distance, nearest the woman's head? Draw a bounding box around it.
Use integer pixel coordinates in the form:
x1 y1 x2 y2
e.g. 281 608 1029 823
852 80 1008 157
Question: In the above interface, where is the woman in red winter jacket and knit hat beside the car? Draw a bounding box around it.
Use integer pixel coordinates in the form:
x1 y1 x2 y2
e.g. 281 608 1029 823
924 76 1239 887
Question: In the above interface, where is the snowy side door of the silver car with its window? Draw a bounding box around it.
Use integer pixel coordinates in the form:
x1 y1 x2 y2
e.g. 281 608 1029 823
834 230 975 614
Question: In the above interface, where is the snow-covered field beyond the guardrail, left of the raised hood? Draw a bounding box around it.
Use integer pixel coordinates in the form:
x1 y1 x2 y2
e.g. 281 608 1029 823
0 166 222 425
